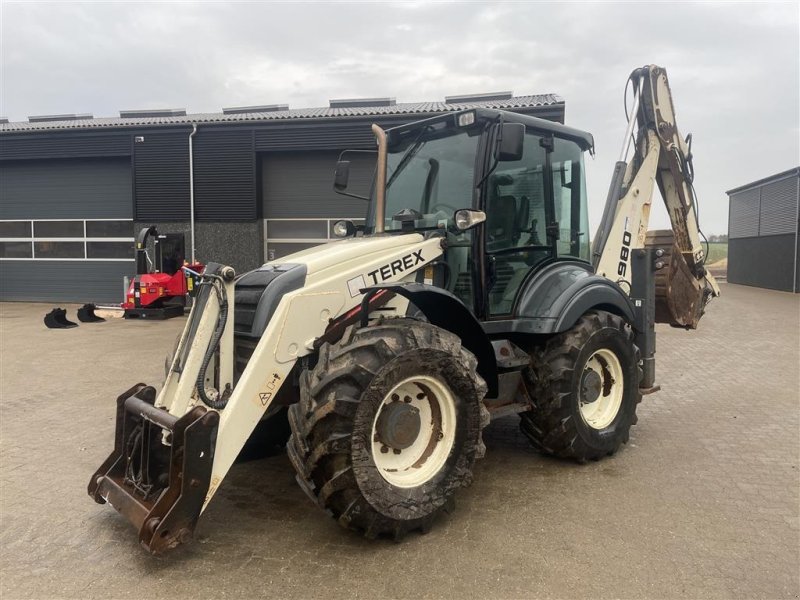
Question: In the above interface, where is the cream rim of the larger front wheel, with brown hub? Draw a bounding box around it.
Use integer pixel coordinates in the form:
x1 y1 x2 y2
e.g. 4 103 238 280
372 375 456 488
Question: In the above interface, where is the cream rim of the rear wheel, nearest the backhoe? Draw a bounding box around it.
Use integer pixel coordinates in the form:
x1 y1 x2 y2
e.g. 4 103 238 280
579 348 624 429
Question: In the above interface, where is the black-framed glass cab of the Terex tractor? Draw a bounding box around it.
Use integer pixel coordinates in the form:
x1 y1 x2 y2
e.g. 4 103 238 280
337 109 593 320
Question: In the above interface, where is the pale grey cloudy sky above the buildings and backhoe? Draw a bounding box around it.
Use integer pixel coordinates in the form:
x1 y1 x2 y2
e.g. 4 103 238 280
0 0 800 234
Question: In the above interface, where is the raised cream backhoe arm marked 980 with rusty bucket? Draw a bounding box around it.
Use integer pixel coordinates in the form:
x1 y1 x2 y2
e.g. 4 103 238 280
592 65 719 329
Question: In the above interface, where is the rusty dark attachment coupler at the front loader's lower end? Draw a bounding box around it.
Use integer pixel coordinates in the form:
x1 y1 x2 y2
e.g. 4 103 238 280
88 383 219 554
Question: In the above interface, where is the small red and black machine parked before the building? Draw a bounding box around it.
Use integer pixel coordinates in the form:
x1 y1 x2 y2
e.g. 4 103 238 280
120 225 205 319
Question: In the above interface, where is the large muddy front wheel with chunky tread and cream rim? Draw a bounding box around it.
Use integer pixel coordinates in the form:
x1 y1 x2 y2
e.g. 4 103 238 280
287 318 489 539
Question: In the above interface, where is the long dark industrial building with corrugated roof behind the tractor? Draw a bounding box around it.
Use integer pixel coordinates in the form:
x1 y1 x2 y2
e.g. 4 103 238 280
0 92 564 302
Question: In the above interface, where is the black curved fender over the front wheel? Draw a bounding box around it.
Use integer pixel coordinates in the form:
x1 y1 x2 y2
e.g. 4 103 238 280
361 282 497 398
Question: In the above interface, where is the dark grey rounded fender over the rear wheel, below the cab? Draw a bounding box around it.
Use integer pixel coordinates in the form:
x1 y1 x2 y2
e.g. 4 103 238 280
483 260 635 335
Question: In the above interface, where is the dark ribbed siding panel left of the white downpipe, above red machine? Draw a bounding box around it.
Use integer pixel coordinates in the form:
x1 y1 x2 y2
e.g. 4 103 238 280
133 130 191 221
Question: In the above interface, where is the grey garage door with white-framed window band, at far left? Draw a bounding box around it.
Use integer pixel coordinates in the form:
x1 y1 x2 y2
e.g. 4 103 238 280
0 158 134 302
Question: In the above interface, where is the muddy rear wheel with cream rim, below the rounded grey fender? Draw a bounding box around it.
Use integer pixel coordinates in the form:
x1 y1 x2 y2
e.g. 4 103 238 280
520 311 642 462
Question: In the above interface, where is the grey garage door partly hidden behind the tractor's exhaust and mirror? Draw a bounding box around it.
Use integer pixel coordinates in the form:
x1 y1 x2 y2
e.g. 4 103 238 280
261 151 375 260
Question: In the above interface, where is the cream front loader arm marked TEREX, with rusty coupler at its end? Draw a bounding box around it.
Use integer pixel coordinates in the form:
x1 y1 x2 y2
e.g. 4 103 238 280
88 234 450 553
